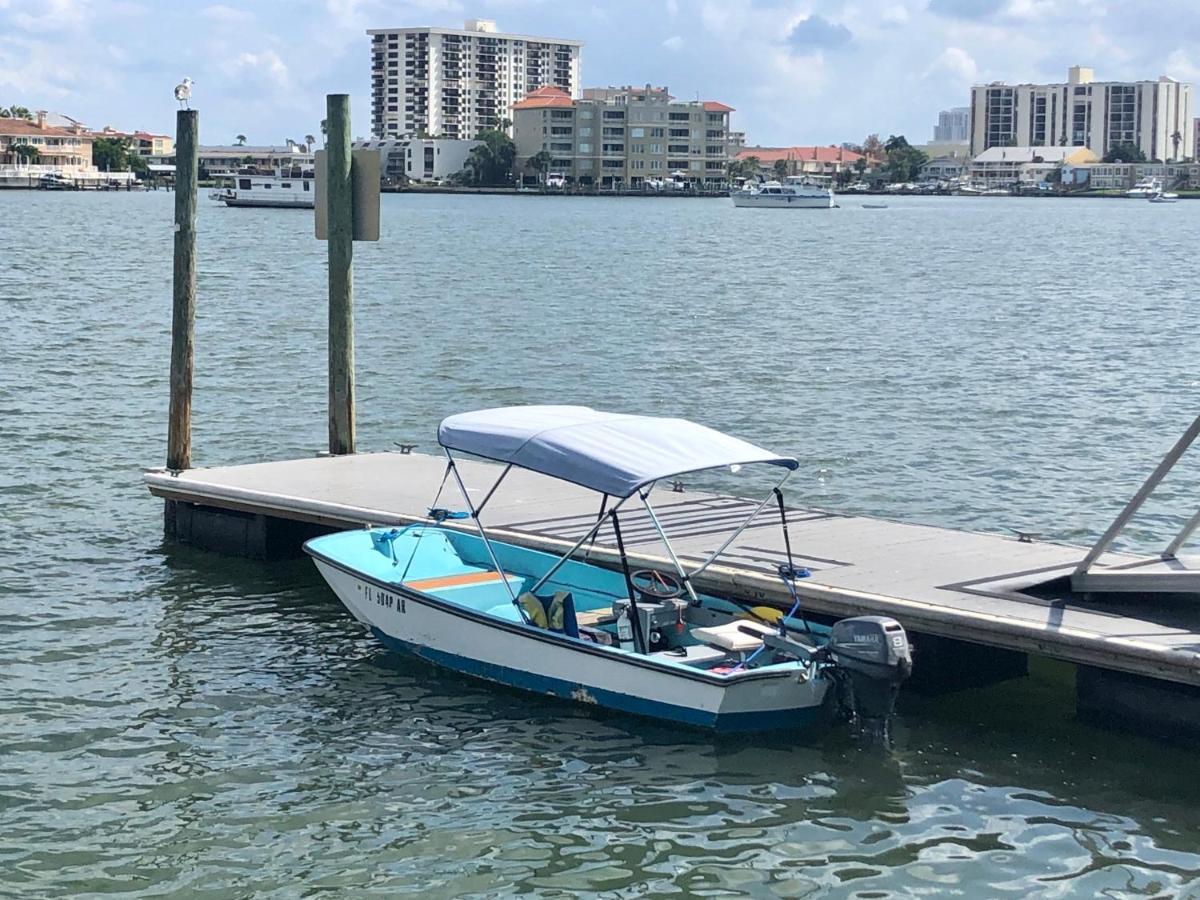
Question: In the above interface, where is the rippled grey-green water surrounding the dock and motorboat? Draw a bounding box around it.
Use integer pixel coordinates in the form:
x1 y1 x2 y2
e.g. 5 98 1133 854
0 192 1200 898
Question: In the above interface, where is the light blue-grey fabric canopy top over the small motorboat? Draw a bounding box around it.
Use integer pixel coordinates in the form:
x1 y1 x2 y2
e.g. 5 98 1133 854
438 407 799 498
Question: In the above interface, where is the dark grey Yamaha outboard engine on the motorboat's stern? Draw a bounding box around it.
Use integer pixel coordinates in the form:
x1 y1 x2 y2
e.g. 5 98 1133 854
826 616 912 746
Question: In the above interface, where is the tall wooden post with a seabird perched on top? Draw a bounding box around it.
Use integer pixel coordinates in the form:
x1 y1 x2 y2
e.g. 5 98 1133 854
167 109 199 470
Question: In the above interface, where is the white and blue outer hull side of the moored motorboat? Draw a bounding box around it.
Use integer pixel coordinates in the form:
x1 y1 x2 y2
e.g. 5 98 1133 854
308 548 829 732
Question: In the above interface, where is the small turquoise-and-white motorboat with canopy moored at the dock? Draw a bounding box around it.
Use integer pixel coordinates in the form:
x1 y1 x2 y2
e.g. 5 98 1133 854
305 406 912 743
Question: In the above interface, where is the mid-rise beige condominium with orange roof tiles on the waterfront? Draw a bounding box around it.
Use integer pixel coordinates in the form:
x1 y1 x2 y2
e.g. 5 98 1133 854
512 85 733 187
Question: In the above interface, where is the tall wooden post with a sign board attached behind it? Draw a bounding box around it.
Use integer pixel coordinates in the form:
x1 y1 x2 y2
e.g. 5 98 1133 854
325 94 354 455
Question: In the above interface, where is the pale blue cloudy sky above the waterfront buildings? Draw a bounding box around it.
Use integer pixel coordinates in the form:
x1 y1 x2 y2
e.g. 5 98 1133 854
0 0 1200 146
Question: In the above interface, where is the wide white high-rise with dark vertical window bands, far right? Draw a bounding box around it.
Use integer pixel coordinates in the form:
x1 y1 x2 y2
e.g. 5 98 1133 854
971 66 1195 161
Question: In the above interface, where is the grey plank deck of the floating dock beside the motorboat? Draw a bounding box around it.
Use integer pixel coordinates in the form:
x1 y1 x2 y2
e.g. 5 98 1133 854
145 452 1200 686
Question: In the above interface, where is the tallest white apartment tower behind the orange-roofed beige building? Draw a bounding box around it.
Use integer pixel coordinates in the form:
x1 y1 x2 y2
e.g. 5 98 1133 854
367 19 583 139
